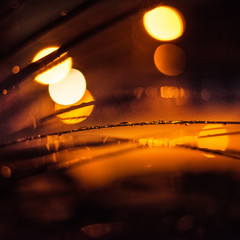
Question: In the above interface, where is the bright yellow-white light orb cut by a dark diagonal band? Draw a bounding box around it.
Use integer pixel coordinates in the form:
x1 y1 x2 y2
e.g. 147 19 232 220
32 47 72 84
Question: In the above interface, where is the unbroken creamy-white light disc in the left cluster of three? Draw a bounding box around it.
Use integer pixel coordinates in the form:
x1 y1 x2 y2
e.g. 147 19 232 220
48 69 86 105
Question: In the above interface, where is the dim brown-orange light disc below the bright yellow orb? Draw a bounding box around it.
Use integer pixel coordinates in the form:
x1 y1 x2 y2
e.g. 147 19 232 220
154 44 186 76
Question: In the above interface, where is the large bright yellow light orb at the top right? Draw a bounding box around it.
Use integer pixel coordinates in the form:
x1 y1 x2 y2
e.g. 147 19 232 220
143 6 184 41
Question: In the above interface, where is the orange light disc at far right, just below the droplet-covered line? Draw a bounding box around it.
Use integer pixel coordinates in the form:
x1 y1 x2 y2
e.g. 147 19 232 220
198 124 229 157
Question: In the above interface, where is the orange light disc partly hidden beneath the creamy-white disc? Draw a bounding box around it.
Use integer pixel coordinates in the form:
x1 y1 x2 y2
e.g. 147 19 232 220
55 90 94 124
